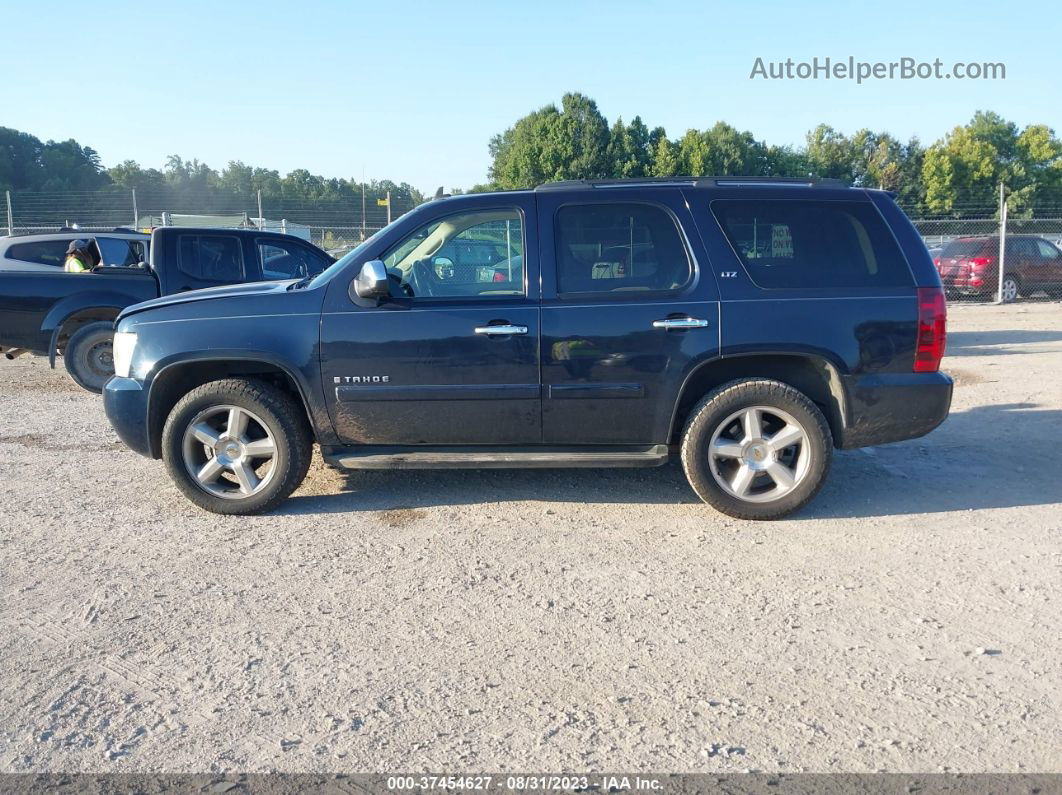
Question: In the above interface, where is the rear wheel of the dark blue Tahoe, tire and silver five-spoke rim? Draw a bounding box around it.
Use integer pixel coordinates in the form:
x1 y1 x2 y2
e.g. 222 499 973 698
682 378 833 519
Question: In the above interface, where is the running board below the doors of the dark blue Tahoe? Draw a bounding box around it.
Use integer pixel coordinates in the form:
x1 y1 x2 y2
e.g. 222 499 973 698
322 445 668 469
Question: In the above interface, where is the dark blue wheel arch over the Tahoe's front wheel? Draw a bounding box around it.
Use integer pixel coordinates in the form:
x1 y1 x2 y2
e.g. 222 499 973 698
148 351 316 459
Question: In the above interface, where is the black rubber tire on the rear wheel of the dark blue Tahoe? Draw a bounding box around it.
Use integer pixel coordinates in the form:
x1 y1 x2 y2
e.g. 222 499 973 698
682 378 834 519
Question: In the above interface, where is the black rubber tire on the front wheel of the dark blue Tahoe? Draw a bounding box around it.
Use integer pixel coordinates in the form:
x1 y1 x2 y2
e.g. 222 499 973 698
162 378 313 516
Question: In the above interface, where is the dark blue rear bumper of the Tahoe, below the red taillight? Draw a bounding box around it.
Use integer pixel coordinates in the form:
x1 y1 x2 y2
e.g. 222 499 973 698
838 373 953 450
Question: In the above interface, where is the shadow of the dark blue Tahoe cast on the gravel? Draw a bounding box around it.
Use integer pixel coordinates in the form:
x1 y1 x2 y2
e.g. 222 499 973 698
277 403 1062 521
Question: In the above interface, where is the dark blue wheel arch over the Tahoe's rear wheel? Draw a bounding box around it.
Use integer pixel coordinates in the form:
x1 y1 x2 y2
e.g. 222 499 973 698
668 352 847 446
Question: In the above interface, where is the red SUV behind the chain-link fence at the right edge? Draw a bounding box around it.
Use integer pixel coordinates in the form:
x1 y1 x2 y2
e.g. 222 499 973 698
933 235 1062 300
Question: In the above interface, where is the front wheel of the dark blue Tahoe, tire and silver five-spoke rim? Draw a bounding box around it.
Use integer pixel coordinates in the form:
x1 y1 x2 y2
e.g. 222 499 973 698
162 378 313 515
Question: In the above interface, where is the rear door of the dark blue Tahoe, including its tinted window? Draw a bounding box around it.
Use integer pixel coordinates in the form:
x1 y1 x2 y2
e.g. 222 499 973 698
536 188 719 445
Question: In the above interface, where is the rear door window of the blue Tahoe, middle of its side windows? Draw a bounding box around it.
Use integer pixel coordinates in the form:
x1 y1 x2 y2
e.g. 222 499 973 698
555 204 691 294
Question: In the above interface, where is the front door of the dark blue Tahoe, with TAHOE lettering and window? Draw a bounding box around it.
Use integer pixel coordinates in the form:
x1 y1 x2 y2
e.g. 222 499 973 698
321 195 542 445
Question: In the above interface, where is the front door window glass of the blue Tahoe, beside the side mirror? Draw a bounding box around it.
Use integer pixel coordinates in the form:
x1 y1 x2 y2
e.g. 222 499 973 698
381 209 525 298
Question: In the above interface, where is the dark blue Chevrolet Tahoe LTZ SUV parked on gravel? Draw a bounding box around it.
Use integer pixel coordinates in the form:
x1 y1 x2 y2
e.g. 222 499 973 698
104 177 952 519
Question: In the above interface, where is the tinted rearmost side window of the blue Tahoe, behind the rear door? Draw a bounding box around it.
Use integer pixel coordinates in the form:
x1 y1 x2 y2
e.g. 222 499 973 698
712 201 912 288
